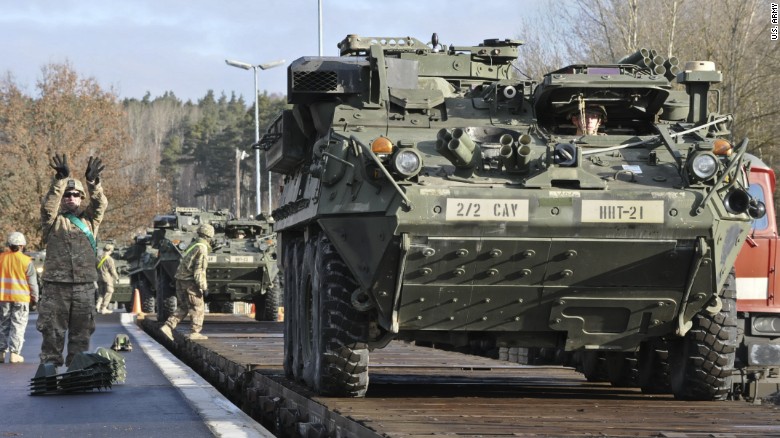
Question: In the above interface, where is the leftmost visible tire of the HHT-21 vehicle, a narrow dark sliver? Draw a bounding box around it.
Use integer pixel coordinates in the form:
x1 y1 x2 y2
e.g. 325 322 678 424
282 237 304 380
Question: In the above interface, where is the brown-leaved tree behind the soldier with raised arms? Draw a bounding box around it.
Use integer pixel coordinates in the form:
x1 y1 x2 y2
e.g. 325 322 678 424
0 63 166 248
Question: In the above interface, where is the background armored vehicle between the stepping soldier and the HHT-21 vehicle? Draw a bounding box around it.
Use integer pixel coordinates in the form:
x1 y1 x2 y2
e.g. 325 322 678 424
206 219 282 321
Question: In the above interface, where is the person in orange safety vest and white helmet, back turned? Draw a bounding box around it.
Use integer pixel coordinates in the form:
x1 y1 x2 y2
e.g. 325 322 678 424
0 231 38 363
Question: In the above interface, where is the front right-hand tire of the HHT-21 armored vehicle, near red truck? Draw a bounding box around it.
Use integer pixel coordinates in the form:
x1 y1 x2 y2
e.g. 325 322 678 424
669 272 738 400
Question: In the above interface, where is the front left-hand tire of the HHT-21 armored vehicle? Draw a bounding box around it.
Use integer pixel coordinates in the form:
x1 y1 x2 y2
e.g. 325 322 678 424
296 233 369 397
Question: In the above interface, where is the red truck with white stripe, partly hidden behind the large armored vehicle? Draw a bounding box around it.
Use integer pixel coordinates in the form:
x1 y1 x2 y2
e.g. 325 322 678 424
735 157 780 399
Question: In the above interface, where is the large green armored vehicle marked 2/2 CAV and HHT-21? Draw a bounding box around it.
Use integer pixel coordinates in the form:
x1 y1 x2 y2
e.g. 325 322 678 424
260 35 762 400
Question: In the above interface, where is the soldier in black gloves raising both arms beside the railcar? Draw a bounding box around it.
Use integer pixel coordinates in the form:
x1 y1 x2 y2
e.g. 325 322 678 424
37 154 108 366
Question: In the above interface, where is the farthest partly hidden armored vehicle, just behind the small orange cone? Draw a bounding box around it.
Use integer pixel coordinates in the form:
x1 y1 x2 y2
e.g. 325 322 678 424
124 230 158 313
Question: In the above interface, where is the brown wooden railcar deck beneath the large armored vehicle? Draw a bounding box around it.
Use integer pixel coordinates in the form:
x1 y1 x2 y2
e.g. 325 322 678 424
139 315 780 437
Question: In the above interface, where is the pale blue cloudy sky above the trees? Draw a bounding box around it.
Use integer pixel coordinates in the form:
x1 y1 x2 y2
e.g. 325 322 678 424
0 0 536 103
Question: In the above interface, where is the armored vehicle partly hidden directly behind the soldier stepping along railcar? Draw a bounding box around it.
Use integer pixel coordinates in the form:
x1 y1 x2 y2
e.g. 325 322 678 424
152 207 231 321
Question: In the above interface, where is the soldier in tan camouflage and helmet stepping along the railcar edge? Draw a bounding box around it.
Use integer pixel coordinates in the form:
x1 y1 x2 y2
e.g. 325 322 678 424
160 224 214 341
